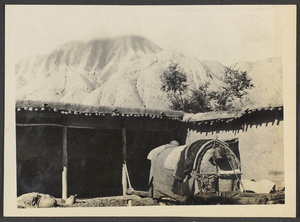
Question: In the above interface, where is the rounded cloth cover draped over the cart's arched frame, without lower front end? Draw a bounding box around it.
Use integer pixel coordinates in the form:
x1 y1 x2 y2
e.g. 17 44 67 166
149 139 240 202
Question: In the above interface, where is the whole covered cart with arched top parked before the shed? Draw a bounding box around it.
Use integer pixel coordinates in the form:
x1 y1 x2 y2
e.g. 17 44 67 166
148 139 243 203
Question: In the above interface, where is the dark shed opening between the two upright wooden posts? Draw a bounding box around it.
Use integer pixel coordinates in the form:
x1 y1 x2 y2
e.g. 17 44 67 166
68 129 122 198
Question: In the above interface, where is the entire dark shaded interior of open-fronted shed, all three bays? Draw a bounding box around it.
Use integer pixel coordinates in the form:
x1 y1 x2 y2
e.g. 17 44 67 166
16 126 185 198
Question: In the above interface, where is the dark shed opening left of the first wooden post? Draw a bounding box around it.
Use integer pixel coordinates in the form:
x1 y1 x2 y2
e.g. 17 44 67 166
16 126 62 197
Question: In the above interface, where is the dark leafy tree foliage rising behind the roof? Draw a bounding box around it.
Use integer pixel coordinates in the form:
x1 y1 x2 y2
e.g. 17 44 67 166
160 62 254 113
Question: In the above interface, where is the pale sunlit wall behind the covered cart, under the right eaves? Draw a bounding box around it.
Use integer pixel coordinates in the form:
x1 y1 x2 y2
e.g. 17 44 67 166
186 121 284 187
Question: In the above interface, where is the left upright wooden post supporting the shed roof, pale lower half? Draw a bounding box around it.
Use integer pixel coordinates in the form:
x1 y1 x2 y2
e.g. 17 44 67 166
62 126 68 200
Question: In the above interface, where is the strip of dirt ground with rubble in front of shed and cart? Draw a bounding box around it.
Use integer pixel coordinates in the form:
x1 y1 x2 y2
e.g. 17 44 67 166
18 190 285 208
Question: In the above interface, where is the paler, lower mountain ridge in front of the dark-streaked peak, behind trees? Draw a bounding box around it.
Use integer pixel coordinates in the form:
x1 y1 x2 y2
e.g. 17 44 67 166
83 51 222 109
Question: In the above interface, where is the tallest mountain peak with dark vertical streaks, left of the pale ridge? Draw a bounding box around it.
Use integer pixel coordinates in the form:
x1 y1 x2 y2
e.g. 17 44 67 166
16 36 161 100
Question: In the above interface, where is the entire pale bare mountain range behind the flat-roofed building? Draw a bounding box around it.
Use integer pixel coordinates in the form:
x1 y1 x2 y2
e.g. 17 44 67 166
16 36 282 109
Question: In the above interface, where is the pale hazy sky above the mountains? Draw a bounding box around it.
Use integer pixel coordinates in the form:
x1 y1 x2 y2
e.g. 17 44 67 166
6 5 286 65
